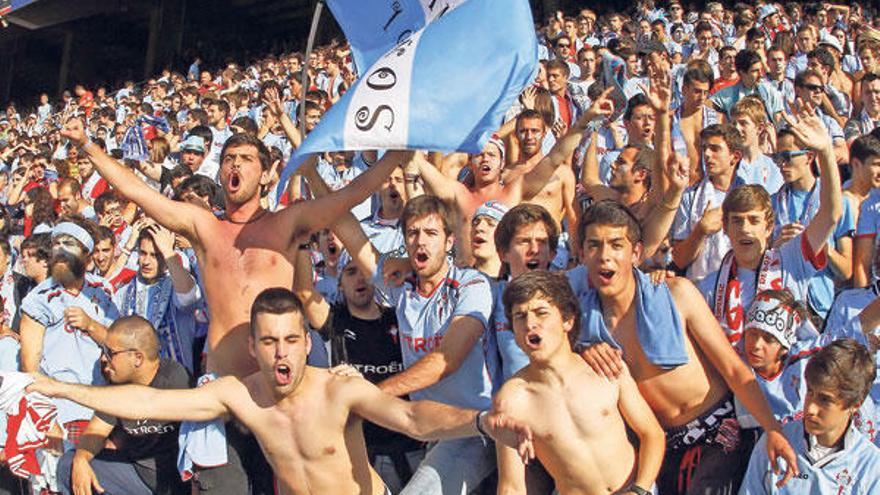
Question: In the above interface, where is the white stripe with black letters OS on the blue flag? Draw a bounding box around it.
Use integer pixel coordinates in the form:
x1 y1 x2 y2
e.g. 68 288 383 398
343 31 423 150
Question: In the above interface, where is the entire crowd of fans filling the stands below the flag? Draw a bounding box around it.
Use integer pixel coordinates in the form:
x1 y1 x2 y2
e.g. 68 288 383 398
0 0 880 495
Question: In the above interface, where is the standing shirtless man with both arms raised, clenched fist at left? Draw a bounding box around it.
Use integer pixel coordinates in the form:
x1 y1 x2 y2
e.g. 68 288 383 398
62 119 410 377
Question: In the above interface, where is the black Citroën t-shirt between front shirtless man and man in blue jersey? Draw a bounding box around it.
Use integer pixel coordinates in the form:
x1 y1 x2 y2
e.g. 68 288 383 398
320 303 422 454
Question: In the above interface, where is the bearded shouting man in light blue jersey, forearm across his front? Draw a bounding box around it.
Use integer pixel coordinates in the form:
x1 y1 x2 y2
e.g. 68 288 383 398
326 195 498 495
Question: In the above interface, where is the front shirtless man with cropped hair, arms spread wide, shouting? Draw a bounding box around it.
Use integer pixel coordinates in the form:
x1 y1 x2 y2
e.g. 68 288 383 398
29 288 530 495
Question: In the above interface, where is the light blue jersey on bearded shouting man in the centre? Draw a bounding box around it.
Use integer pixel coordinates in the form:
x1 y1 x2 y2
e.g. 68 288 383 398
373 255 498 409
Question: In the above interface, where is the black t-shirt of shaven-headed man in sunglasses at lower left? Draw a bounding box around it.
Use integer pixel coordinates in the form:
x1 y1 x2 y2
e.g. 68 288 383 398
95 359 193 493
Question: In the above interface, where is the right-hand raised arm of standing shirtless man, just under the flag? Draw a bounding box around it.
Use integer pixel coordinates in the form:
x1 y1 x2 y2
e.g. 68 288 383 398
286 151 412 243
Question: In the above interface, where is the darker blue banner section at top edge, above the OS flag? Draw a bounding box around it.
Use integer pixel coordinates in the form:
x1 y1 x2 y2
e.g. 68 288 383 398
327 0 466 74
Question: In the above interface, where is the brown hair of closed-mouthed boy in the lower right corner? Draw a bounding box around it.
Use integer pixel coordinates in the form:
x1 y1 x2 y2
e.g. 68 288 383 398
804 339 877 407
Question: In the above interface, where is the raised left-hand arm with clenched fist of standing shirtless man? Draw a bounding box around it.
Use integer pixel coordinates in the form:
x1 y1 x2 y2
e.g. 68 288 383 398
61 119 211 240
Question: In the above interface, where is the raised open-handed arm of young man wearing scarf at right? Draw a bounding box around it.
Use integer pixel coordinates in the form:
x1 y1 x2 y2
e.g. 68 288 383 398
783 101 843 252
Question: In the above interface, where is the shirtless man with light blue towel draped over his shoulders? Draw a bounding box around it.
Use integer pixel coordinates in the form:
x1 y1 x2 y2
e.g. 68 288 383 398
569 201 796 494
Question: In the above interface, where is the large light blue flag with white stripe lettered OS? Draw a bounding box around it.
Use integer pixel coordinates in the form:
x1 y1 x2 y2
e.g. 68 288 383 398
279 0 538 201
